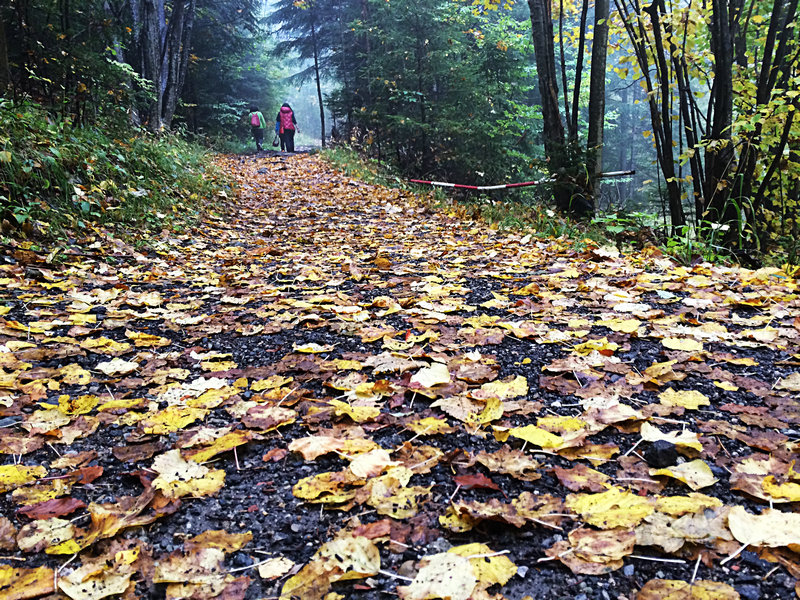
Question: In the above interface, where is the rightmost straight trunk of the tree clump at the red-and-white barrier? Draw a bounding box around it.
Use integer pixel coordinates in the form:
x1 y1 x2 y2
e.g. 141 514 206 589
586 0 608 196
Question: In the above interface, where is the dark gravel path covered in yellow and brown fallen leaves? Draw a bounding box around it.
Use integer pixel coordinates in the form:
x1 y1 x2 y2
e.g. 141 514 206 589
0 155 800 600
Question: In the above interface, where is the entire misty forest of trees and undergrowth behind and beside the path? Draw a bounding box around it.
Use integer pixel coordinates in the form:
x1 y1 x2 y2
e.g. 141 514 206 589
0 0 800 264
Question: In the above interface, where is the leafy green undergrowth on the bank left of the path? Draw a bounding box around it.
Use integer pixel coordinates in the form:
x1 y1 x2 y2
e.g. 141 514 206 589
0 98 230 243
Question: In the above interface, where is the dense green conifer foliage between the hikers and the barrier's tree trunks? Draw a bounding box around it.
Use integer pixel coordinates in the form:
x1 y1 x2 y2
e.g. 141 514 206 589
318 0 541 183
